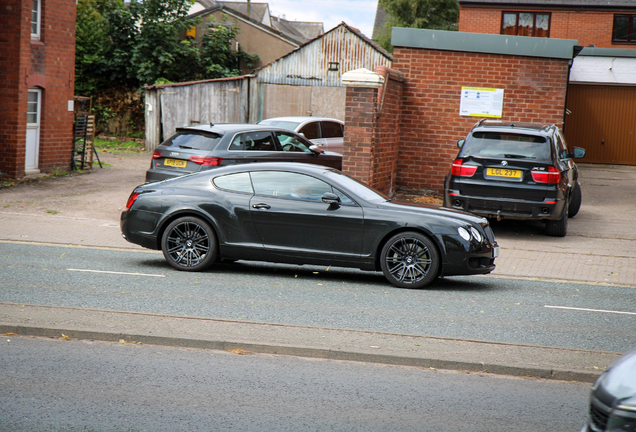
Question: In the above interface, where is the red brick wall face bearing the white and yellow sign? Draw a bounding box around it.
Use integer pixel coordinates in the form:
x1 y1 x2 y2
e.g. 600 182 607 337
393 47 569 192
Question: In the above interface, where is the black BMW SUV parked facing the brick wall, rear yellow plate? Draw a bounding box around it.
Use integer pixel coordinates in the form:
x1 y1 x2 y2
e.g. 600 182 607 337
444 120 585 237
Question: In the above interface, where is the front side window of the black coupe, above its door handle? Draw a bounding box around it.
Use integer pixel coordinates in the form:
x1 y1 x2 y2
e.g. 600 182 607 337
251 171 332 201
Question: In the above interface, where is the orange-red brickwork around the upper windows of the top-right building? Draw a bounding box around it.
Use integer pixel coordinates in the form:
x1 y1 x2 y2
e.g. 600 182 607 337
459 6 636 48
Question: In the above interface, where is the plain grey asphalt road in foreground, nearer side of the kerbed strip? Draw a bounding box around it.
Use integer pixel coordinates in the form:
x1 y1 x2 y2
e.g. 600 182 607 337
0 336 590 432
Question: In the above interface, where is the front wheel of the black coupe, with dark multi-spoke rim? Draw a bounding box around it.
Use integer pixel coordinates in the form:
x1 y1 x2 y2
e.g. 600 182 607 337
380 232 440 289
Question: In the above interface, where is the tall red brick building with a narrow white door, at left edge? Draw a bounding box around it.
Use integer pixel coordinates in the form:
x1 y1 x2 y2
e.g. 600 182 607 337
0 0 76 178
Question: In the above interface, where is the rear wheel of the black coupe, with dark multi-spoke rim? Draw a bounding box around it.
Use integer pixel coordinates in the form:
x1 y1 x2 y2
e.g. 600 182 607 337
161 216 217 271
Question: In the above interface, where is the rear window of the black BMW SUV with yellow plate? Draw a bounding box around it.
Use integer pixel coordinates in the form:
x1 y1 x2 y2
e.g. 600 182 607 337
461 132 550 161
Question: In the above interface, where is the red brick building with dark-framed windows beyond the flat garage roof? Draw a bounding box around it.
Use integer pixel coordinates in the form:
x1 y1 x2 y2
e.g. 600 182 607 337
459 0 636 48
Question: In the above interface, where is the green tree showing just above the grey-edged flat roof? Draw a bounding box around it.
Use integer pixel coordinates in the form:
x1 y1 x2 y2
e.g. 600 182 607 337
377 0 459 51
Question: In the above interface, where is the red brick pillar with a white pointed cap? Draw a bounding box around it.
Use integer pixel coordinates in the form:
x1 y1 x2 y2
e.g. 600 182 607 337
342 69 382 186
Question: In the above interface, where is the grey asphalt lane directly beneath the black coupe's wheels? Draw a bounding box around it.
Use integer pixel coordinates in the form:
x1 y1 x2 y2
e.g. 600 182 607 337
0 243 636 352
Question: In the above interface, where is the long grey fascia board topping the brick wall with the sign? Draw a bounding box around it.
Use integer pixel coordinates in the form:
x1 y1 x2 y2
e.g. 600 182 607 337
391 27 577 59
